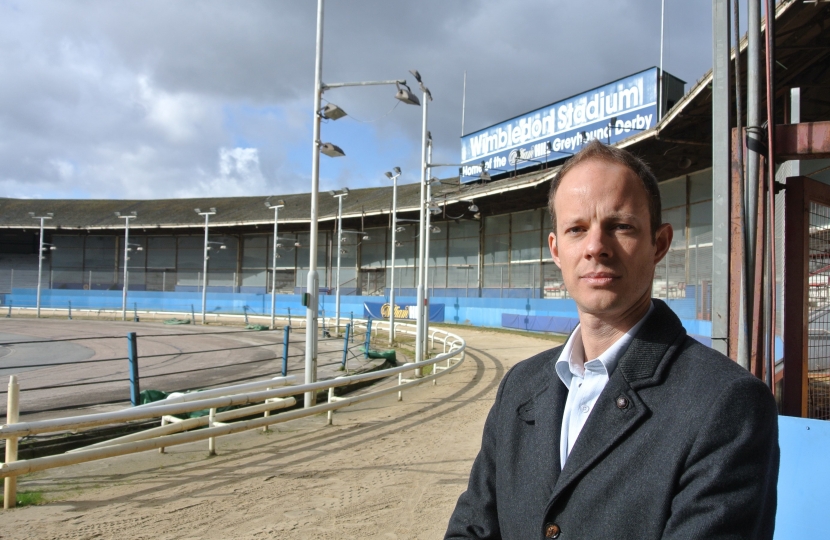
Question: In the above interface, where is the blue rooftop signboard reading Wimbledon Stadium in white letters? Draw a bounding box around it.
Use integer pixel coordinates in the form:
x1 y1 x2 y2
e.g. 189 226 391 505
461 68 657 182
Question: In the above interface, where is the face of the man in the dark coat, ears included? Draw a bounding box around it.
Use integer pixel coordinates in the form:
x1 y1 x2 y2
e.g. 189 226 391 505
548 159 673 318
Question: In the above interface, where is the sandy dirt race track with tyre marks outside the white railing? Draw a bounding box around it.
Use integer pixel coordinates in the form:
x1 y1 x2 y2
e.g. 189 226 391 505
0 329 555 540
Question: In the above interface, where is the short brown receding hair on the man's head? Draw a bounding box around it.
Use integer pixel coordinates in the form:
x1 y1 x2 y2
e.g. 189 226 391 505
548 139 663 237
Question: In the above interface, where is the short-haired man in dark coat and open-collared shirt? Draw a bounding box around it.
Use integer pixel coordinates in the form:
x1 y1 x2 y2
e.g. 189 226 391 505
446 141 779 540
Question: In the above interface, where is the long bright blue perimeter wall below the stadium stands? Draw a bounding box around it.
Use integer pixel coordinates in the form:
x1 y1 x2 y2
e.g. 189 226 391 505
0 289 712 345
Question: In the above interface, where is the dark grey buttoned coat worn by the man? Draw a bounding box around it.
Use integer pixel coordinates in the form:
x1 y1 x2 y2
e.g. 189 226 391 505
446 300 779 540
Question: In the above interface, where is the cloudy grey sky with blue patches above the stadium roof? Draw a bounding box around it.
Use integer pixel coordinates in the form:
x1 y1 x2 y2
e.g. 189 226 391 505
0 0 712 199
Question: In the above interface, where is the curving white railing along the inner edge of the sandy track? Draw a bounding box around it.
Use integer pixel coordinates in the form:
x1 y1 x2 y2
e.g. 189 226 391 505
0 319 466 508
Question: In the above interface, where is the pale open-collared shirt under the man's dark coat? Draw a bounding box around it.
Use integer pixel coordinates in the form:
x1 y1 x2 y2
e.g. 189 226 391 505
556 303 654 468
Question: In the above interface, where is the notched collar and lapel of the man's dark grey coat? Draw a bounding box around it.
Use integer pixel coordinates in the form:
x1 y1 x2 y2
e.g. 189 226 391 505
550 300 685 504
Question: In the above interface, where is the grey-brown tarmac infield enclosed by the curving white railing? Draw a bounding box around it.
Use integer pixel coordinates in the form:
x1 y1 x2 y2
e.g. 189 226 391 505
0 318 377 421
